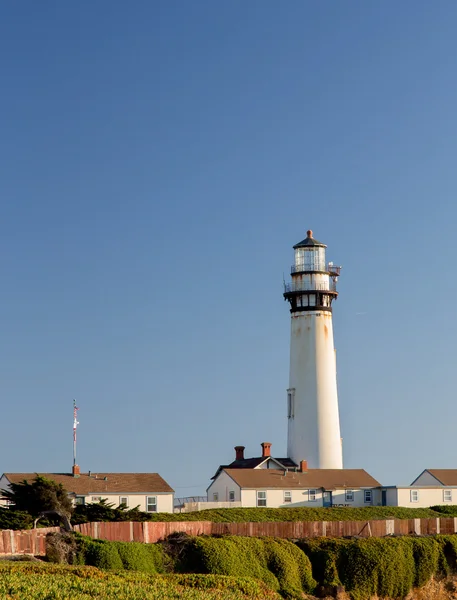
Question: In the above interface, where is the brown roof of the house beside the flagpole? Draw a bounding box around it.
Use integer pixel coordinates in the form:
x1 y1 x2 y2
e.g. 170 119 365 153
4 473 174 496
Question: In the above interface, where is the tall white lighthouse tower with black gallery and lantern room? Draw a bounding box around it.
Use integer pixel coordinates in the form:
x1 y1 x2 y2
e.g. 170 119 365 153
284 230 343 469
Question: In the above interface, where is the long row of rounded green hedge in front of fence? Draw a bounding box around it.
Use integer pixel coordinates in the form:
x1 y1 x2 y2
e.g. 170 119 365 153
47 534 457 600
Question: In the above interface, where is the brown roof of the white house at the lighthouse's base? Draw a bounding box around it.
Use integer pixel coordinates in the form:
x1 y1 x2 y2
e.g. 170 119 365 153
224 469 381 490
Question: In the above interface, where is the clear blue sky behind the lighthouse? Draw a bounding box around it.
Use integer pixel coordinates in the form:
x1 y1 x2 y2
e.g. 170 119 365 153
0 0 457 496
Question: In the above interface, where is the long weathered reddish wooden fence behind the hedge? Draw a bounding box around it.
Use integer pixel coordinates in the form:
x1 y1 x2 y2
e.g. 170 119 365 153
0 517 457 555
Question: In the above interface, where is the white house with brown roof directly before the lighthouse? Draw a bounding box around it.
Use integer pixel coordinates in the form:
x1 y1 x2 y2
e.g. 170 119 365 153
207 461 380 508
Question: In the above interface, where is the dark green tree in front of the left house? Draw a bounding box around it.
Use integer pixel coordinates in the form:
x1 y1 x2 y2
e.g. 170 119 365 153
3 475 73 530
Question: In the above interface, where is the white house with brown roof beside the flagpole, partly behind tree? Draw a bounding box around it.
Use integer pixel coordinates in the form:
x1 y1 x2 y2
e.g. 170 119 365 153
0 465 174 513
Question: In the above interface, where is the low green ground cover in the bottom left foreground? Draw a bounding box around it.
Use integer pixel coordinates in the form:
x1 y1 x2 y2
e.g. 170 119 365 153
0 562 280 600
